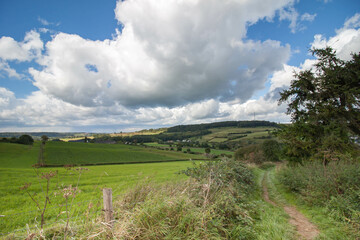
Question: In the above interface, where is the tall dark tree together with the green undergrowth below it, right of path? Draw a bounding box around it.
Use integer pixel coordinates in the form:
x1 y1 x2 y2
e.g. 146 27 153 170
277 47 360 235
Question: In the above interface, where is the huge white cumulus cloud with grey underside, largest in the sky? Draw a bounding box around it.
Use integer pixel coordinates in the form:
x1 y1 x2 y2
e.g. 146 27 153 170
30 0 291 107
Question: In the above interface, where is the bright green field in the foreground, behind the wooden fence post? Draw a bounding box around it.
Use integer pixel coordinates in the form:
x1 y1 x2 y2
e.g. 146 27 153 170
0 143 195 234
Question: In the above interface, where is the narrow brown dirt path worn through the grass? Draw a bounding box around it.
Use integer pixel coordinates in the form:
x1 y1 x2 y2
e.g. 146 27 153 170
262 172 319 240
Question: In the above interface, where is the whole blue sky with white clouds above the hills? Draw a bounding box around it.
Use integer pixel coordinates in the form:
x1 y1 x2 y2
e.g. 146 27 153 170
0 0 360 132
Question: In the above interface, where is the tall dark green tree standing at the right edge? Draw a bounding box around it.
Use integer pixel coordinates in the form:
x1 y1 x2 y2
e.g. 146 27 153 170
278 47 360 161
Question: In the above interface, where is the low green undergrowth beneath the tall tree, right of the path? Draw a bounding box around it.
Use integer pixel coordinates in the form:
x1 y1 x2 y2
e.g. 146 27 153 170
279 161 360 227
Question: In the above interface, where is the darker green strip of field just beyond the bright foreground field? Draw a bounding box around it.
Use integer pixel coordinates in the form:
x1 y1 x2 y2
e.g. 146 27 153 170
45 142 204 165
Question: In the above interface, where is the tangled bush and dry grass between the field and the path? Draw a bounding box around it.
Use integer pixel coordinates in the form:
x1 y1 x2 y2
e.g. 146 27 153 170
107 160 256 239
